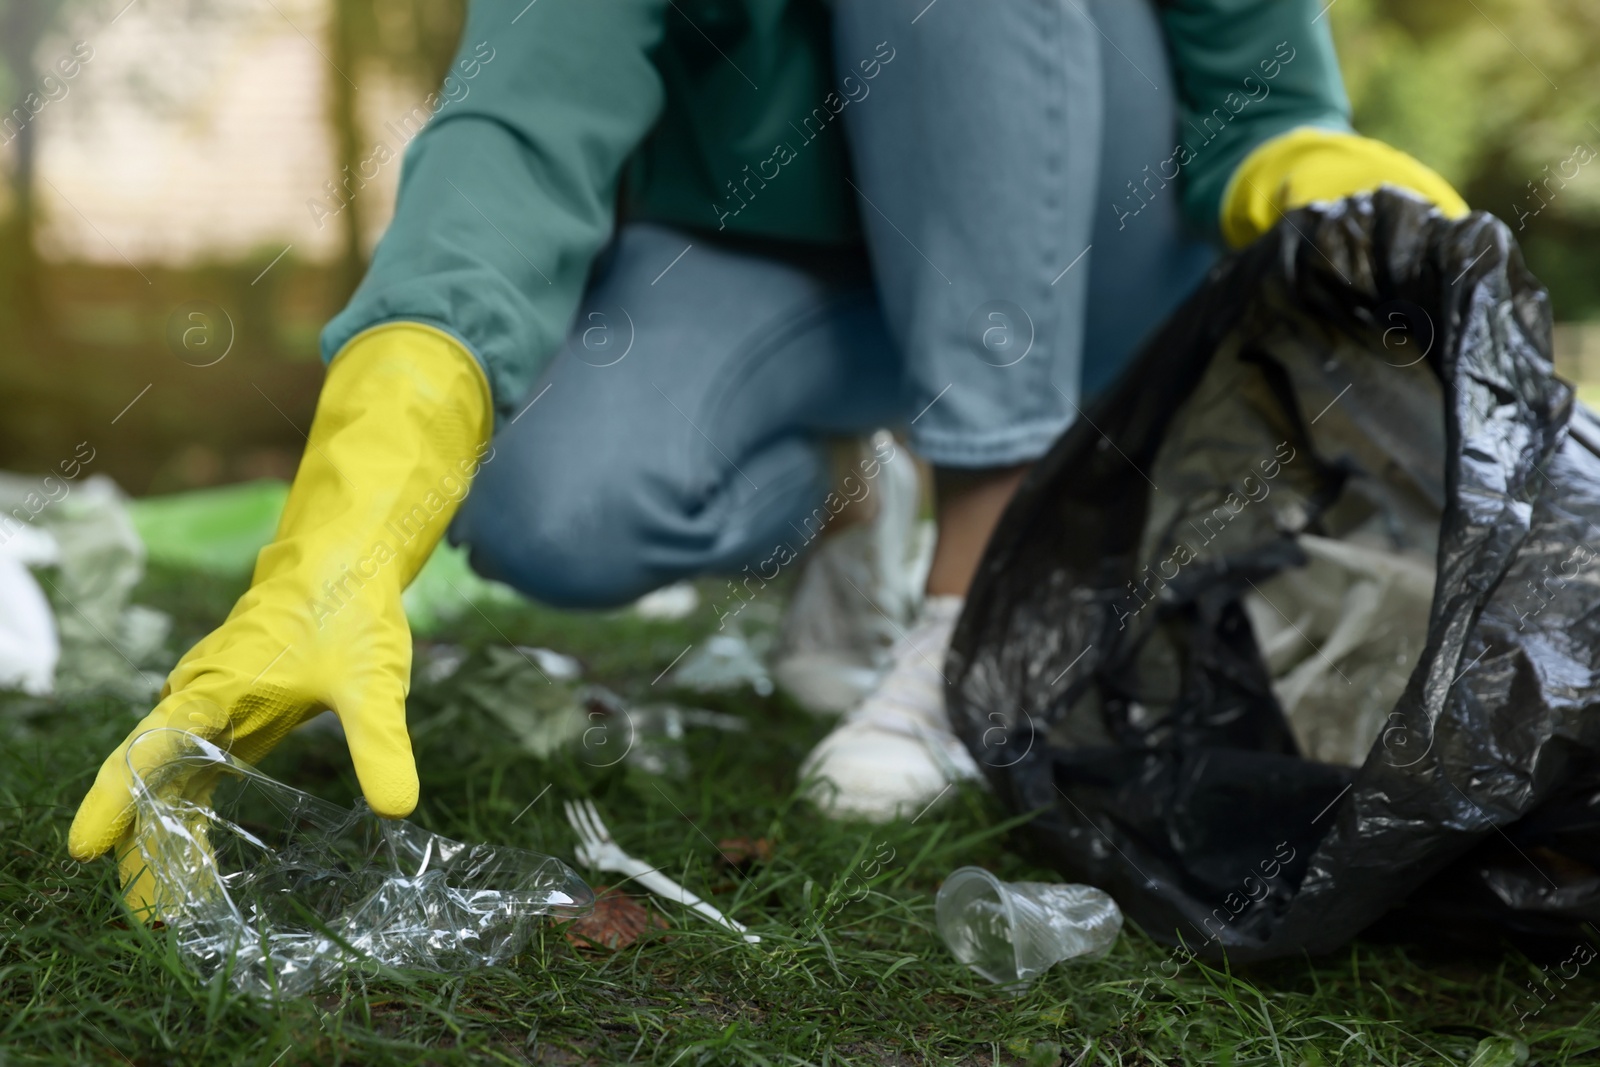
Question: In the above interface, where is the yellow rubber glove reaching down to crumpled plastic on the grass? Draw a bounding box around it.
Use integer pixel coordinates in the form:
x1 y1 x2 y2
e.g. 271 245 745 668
67 323 493 909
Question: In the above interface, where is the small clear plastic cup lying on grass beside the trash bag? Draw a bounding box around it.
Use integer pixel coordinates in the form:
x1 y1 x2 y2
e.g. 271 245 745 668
934 867 1122 985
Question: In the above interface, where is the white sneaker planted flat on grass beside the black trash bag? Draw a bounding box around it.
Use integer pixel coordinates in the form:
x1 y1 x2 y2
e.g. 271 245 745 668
800 597 979 822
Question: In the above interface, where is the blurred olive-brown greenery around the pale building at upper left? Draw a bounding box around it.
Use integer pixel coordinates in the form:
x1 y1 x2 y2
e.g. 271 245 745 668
0 0 466 494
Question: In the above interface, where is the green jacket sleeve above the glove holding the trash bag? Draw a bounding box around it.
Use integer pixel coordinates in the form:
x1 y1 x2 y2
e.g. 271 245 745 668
1162 0 1350 234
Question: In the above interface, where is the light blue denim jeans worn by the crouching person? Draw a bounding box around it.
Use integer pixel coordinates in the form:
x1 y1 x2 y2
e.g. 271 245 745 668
451 0 1214 606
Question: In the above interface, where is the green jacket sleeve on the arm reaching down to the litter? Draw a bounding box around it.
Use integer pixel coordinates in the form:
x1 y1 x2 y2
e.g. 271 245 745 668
322 0 669 418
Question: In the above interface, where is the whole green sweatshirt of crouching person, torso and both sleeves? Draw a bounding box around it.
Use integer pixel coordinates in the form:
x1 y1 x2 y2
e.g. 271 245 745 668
318 0 1349 418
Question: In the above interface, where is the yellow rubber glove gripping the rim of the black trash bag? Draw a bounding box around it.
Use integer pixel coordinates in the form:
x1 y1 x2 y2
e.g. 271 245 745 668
1221 126 1467 248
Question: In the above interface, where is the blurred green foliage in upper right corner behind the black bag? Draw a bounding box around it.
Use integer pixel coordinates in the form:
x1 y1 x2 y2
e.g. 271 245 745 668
1328 0 1600 320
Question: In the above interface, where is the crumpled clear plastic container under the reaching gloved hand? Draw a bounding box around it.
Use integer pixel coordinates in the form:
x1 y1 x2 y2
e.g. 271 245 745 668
128 729 594 998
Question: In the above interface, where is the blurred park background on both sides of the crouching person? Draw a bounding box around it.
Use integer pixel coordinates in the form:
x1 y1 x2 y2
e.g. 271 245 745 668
0 0 1600 494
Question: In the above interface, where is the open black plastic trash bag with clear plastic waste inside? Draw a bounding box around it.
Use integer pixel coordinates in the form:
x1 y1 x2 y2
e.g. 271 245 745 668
947 190 1600 960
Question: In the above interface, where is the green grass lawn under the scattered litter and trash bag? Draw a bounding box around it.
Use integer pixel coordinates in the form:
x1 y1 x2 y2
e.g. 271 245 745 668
0 563 1600 1067
